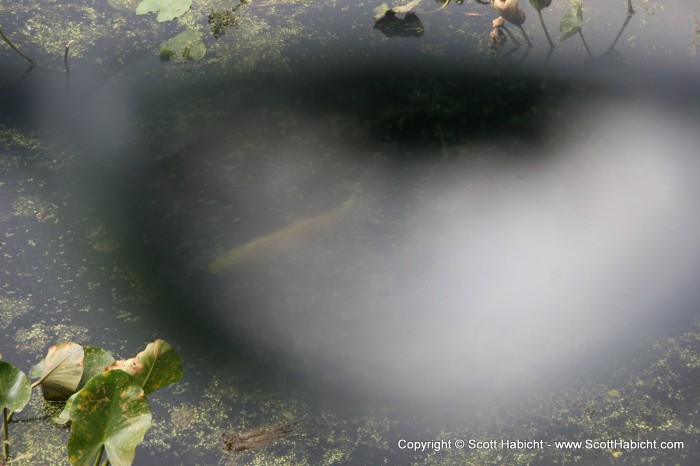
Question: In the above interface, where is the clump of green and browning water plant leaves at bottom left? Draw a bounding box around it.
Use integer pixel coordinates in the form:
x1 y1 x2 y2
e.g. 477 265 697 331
0 340 183 466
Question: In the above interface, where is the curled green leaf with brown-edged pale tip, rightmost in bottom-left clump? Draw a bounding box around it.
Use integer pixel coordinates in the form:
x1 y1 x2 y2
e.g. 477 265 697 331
107 340 183 395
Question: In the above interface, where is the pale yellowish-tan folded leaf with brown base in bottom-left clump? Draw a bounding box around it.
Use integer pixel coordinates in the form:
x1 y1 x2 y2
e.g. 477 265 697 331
33 342 85 401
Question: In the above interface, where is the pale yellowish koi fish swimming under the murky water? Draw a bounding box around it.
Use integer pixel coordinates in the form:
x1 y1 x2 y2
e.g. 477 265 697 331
207 188 357 274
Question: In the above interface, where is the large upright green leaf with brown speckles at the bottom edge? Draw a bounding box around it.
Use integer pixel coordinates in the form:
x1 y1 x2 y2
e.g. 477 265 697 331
68 371 151 466
